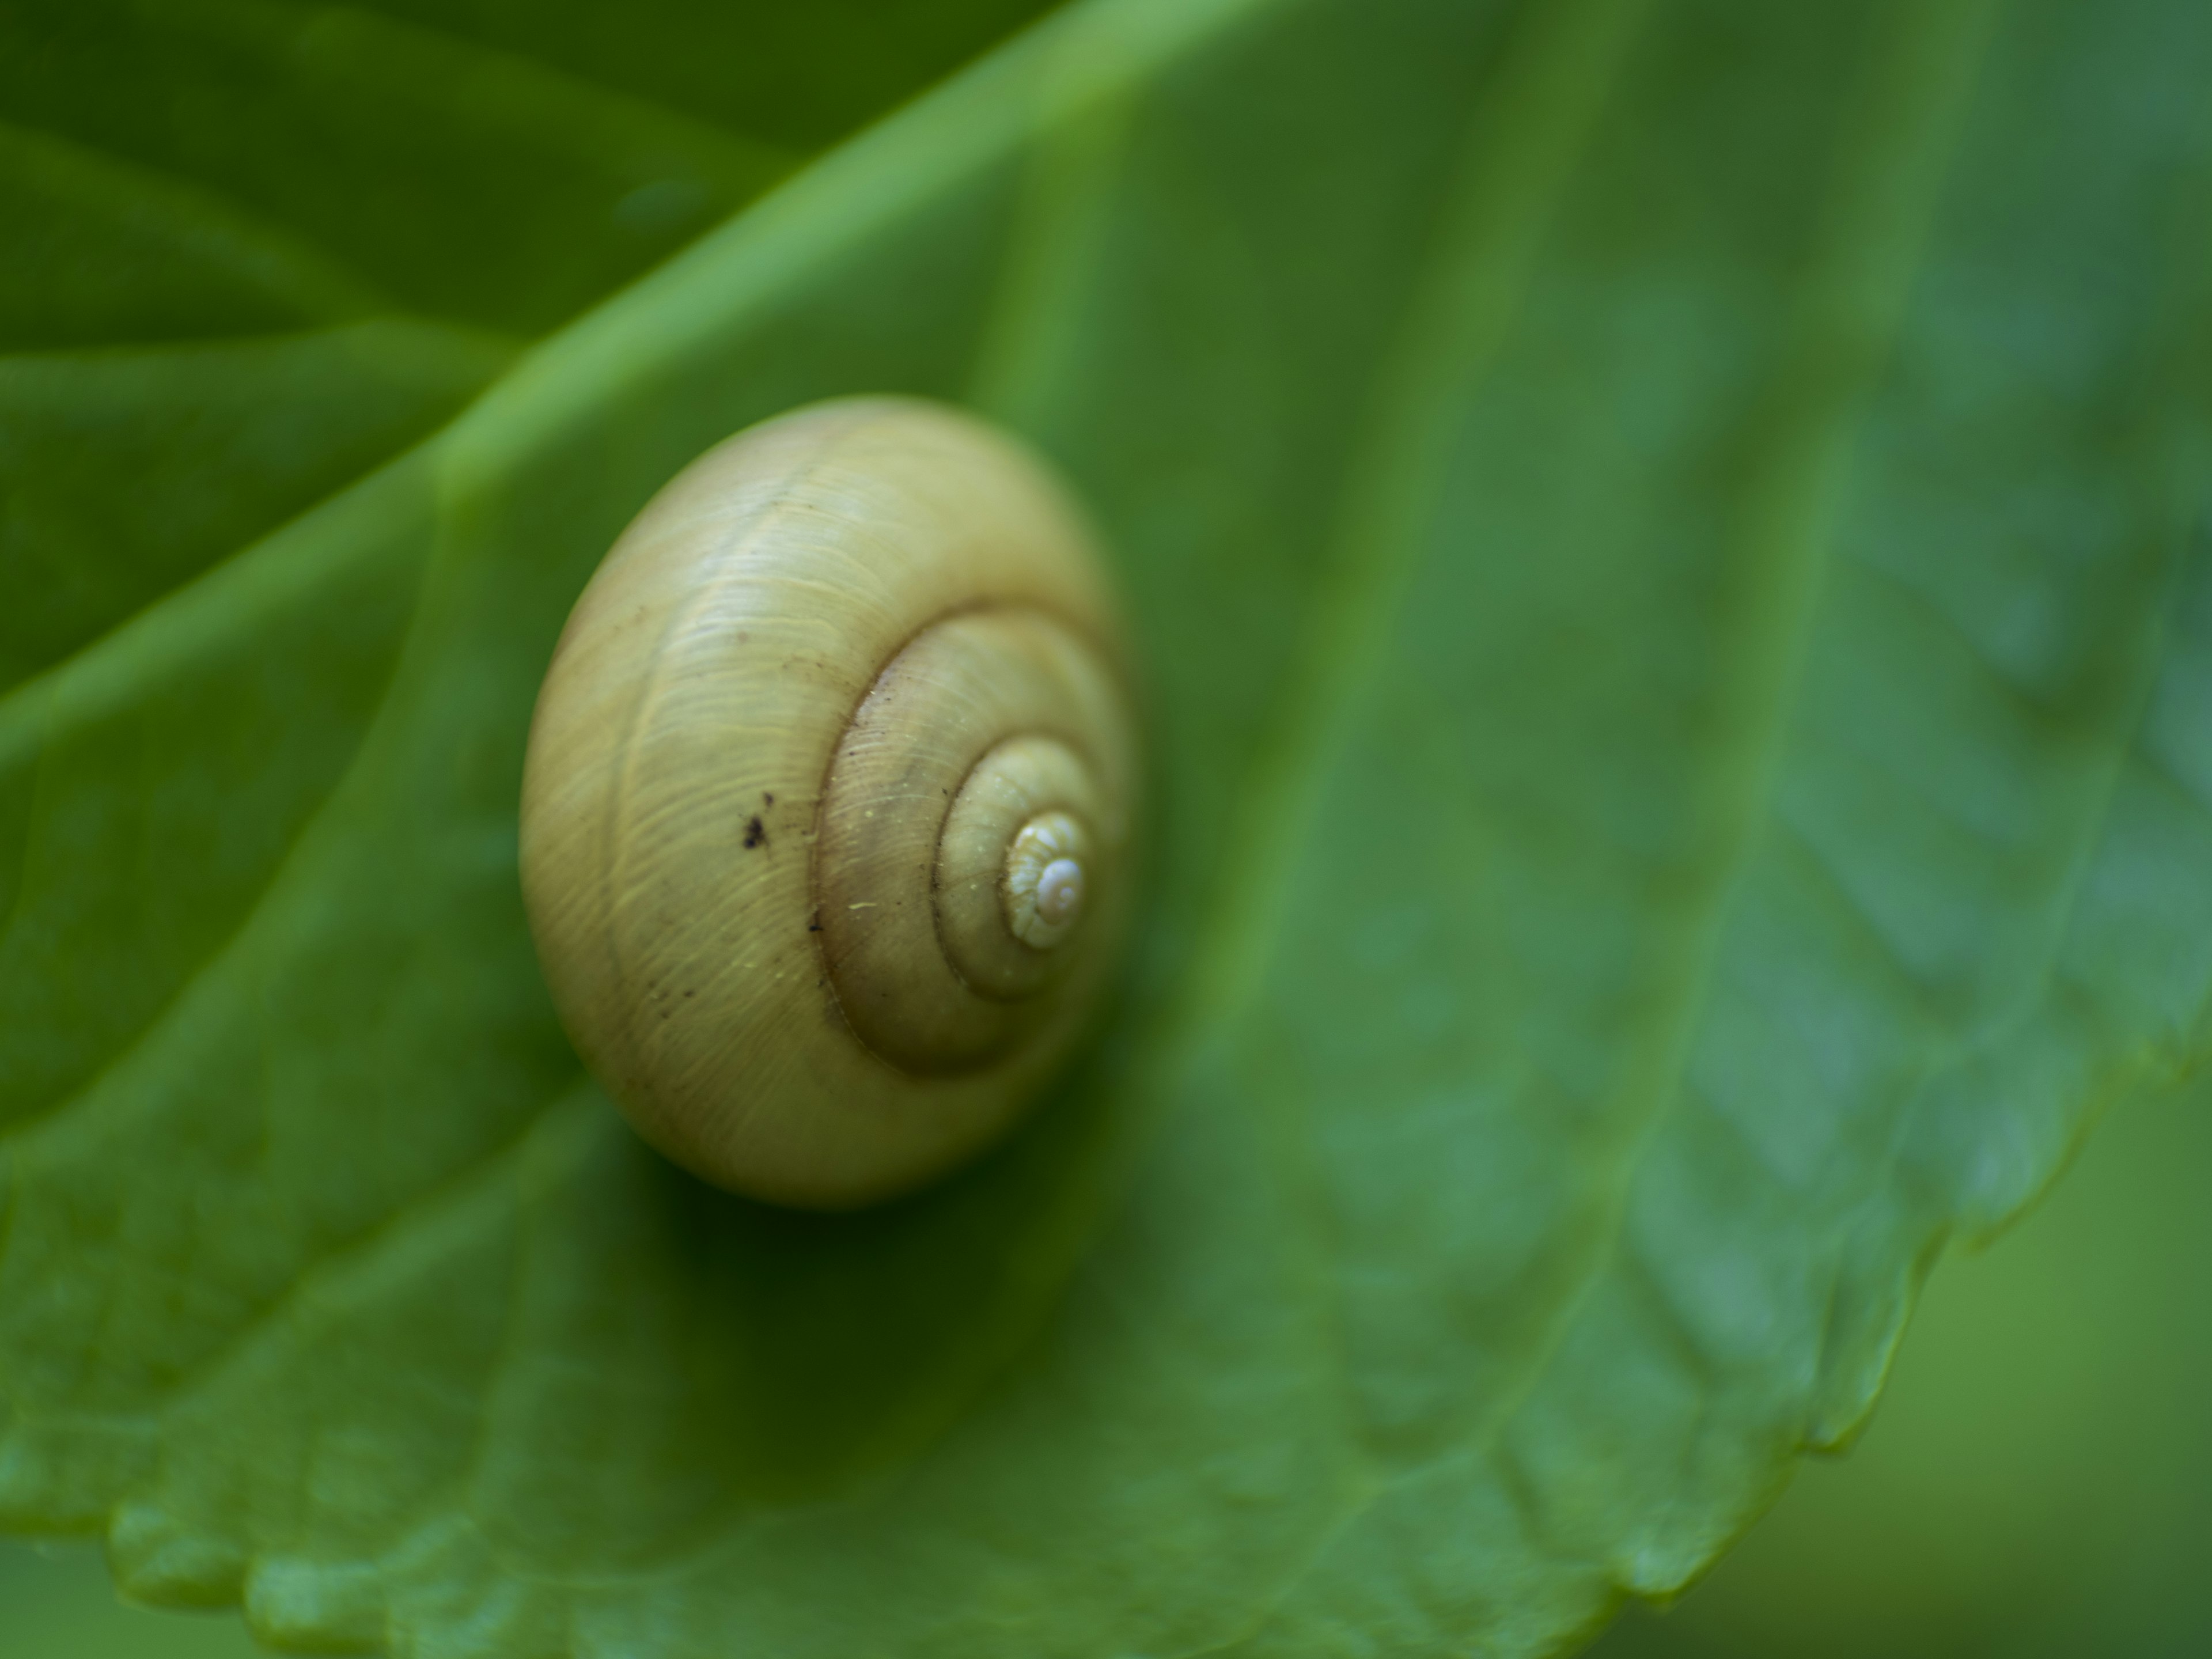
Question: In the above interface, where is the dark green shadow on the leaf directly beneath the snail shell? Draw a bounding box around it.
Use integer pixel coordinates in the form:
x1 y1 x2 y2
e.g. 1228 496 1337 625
524 1044 1132 1551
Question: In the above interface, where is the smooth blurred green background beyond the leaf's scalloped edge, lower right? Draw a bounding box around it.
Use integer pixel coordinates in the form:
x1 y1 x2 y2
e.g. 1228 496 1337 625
1590 1075 2212 1659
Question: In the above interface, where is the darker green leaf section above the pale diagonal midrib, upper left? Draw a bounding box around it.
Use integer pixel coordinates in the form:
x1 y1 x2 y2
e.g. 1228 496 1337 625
0 0 1037 688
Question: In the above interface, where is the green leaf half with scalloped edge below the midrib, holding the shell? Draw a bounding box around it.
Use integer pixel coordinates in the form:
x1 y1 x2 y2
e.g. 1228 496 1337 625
0 0 2212 1659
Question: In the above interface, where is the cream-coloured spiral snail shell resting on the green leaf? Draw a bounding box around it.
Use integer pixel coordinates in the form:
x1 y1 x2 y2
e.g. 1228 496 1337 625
522 398 1137 1208
